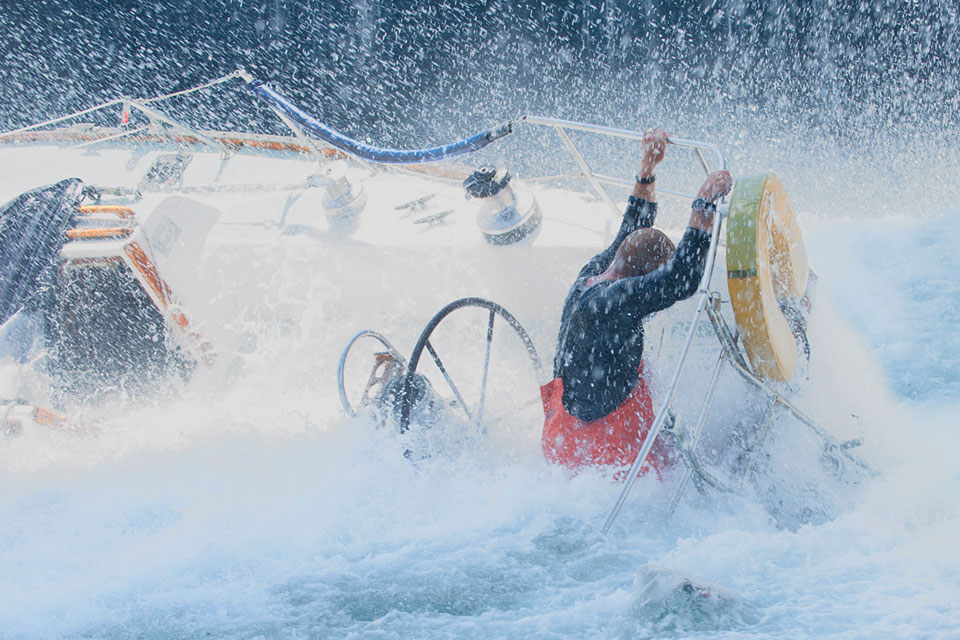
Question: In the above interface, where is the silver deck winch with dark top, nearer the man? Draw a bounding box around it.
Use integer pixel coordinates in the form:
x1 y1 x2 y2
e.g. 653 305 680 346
463 164 543 245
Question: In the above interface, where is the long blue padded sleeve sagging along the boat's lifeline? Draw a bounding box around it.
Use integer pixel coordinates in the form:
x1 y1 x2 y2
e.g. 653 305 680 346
248 81 513 164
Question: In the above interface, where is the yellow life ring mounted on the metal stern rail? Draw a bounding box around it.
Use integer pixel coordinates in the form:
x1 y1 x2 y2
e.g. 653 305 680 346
727 173 810 381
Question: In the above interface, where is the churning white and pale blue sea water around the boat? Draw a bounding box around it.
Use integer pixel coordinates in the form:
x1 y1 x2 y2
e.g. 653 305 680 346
0 210 960 638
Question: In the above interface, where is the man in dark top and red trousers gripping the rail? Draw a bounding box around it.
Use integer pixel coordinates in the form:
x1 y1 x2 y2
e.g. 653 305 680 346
540 129 733 473
